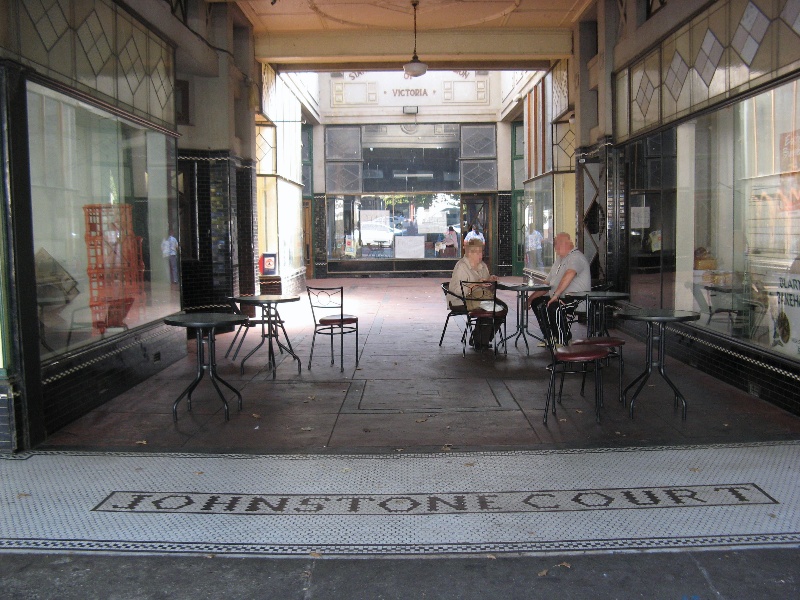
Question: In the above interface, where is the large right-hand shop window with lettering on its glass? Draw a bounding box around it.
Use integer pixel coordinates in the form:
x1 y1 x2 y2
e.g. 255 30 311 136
675 81 800 360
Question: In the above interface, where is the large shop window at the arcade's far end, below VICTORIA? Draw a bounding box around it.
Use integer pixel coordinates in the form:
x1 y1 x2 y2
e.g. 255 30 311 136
325 123 496 260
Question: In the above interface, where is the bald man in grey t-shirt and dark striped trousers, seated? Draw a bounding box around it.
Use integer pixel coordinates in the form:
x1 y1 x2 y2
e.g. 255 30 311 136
528 233 592 346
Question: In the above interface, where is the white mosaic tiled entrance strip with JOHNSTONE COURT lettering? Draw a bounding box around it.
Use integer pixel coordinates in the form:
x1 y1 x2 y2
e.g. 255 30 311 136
0 442 800 556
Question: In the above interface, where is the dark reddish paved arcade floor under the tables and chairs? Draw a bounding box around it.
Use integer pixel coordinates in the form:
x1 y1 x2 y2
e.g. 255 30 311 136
42 278 800 453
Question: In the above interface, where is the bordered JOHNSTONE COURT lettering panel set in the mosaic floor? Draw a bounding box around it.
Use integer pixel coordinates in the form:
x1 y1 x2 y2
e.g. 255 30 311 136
94 483 778 515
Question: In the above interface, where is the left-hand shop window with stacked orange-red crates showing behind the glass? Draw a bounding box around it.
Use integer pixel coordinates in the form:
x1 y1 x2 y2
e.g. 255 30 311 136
28 83 180 358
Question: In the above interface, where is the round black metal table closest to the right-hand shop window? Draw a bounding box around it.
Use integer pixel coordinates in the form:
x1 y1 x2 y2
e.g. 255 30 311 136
616 308 700 419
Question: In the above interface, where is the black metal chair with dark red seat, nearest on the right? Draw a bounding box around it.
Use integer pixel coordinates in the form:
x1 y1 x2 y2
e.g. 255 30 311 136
534 303 609 425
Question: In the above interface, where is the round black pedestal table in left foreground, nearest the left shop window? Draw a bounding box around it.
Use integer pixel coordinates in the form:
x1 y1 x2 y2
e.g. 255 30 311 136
164 313 247 421
